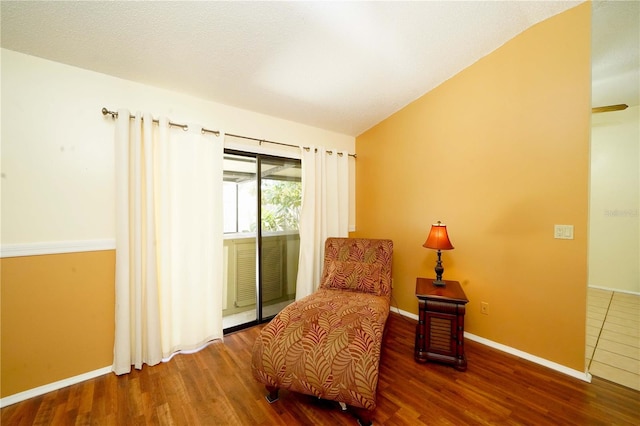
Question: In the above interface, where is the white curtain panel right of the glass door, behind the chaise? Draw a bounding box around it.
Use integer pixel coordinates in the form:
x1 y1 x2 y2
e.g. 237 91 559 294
296 147 349 300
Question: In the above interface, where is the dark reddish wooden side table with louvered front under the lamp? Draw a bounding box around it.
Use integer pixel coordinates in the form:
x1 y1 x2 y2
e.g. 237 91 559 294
414 278 469 371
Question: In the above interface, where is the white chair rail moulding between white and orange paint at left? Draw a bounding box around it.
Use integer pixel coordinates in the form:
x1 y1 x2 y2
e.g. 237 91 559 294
0 239 116 257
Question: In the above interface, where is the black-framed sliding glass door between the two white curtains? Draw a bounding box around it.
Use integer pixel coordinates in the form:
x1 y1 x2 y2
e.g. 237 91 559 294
223 150 302 331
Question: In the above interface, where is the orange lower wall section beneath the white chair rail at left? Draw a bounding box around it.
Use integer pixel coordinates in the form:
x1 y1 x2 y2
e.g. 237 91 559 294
0 250 115 397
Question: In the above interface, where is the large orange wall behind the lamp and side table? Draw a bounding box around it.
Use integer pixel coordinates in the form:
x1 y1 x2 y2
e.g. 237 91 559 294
352 3 591 371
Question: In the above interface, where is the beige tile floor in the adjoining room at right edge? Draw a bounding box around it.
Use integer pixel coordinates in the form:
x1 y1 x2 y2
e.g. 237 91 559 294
586 288 640 390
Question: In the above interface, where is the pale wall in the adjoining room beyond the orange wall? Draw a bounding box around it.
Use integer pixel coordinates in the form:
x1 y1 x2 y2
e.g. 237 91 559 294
589 106 640 293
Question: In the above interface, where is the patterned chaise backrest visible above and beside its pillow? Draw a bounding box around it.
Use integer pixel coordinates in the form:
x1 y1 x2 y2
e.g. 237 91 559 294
323 238 393 296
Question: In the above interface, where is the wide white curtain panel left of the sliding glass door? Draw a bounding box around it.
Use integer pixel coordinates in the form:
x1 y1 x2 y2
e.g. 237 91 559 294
112 110 223 374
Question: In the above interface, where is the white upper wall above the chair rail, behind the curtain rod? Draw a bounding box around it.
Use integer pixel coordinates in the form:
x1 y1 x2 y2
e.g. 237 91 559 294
1 49 355 247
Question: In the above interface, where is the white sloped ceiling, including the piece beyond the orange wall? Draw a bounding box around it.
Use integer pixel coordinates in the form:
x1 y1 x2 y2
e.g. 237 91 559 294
1 1 640 136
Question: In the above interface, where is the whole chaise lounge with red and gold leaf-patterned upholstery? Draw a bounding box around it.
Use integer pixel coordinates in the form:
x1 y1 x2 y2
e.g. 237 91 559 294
251 238 393 422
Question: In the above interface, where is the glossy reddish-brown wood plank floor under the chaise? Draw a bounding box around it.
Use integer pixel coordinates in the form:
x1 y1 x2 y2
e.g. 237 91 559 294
0 314 640 425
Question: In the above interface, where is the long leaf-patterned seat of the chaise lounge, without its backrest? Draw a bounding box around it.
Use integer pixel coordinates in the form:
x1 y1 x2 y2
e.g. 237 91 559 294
252 288 389 410
